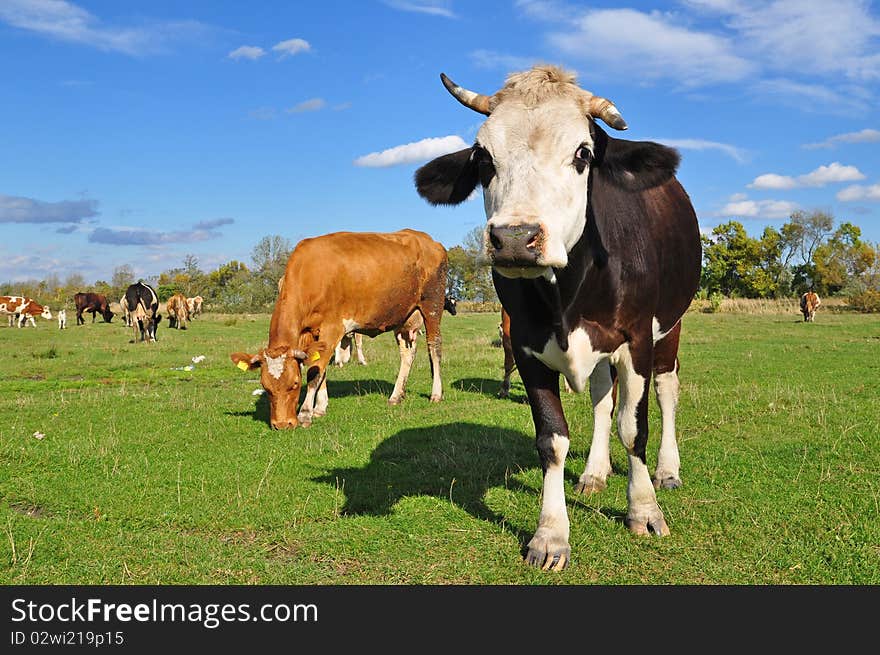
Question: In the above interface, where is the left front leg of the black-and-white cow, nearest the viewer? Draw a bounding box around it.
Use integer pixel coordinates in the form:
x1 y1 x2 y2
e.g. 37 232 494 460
519 357 571 571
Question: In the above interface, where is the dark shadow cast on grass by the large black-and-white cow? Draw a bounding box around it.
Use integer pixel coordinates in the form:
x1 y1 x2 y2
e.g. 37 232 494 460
312 423 623 553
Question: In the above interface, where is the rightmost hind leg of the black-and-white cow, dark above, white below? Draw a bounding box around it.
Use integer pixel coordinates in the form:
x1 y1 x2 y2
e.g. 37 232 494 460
653 323 681 489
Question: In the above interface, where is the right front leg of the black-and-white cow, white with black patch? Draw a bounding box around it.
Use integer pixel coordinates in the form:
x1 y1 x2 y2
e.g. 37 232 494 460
612 342 669 536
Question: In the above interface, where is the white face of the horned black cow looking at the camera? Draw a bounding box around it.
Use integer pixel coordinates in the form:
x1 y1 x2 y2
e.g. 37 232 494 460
475 97 593 278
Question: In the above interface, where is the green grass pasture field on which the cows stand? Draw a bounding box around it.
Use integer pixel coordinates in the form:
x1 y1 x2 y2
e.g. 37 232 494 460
0 310 880 585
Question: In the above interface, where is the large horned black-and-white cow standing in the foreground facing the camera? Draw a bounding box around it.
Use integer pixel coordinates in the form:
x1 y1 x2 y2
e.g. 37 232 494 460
415 66 701 570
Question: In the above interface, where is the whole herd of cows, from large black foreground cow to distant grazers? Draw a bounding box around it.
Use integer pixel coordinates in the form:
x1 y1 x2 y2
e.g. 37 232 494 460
0 66 832 570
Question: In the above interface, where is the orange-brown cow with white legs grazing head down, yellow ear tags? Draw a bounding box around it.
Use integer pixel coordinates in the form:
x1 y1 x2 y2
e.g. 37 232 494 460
230 229 448 429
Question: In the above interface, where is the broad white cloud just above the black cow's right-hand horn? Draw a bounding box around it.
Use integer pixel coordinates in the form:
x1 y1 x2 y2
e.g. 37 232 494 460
548 9 755 86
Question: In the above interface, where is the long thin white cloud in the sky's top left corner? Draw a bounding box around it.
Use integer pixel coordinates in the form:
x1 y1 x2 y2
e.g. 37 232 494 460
0 0 206 55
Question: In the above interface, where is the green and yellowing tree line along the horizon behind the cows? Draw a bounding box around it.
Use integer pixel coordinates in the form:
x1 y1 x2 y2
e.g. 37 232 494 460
0 211 880 312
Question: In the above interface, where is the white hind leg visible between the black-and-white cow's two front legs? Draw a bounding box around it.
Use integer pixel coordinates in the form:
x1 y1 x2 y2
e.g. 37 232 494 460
575 359 617 494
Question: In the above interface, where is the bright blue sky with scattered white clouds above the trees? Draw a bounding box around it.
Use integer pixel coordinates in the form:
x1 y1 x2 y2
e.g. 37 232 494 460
0 0 880 282
